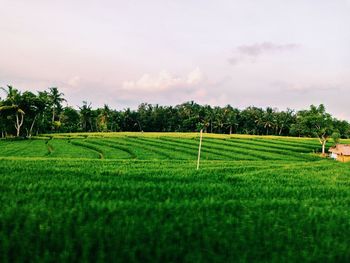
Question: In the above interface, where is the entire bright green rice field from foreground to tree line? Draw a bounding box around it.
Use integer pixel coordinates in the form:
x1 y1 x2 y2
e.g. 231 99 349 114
0 133 350 262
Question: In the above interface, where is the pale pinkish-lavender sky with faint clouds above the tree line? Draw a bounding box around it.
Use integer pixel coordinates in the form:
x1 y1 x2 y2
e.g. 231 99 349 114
0 0 350 120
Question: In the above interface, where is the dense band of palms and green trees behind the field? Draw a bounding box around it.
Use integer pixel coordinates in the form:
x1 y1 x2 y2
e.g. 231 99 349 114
0 86 350 139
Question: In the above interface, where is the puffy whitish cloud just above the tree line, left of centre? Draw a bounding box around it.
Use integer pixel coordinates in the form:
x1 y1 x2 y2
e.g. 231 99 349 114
122 68 203 92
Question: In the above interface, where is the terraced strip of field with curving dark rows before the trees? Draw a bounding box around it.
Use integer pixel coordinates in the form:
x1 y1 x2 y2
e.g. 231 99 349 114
0 135 336 161
